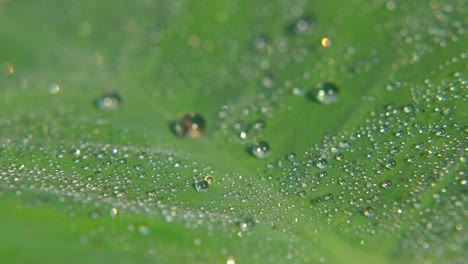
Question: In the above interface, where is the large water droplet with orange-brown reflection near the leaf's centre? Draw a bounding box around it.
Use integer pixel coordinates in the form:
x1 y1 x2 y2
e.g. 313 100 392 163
174 113 205 138
